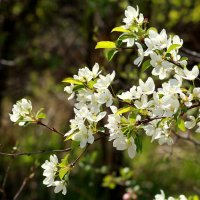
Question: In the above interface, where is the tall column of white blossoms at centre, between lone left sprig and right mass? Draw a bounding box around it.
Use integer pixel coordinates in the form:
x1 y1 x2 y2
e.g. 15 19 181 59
64 63 115 148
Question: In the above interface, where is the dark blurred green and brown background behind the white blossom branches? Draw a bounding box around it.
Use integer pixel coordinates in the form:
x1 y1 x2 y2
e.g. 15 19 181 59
0 0 200 200
